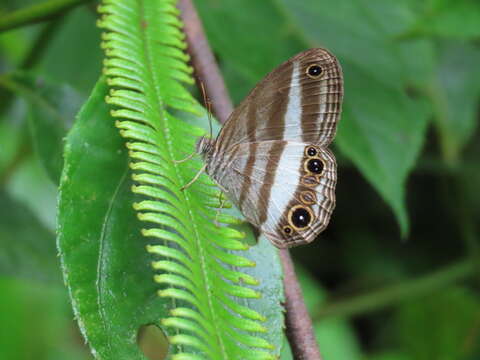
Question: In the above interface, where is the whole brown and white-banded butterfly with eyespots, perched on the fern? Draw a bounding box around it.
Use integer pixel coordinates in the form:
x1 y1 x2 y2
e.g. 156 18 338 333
196 48 343 248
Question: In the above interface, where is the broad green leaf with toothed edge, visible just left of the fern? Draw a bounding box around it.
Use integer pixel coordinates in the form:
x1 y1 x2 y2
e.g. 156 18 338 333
58 81 171 360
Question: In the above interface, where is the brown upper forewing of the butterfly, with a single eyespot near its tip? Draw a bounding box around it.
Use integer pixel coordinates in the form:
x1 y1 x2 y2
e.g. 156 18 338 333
216 49 343 153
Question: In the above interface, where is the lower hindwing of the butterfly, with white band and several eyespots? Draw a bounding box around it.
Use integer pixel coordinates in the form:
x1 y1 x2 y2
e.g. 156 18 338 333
216 140 337 248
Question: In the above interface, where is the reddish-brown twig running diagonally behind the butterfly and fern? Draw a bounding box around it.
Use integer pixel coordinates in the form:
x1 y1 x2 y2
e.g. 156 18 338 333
178 0 321 360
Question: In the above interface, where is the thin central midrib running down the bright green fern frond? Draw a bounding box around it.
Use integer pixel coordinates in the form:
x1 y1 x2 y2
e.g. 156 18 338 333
138 0 228 359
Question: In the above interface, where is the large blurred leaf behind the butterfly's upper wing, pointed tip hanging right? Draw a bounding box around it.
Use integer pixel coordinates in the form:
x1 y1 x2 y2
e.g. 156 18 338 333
197 0 433 234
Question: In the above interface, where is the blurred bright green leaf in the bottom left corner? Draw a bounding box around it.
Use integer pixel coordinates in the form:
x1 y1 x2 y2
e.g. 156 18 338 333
0 278 88 360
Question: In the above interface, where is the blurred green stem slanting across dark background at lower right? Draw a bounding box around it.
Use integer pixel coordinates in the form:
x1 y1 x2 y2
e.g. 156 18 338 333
313 259 476 320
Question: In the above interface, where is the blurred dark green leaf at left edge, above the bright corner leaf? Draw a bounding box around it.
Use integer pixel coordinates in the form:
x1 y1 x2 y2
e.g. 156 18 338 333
0 192 61 284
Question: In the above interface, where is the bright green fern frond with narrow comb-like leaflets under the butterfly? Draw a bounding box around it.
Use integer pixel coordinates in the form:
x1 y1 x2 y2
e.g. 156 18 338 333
99 0 276 360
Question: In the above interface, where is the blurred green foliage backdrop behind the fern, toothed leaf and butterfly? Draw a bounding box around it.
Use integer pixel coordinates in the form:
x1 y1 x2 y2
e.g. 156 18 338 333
0 0 480 360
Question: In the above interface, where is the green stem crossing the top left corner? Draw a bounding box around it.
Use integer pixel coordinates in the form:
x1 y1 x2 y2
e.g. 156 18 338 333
0 0 92 31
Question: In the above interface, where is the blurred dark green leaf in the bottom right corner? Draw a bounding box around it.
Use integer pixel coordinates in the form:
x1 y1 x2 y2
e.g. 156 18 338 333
395 287 480 360
